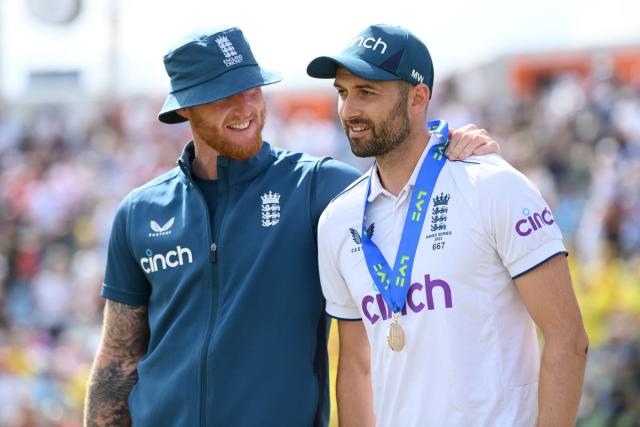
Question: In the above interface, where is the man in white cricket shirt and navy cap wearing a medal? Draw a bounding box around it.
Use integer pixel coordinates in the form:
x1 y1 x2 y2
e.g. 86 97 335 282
307 25 588 427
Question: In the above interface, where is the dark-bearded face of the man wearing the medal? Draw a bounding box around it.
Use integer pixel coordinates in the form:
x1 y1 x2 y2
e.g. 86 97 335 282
334 68 411 157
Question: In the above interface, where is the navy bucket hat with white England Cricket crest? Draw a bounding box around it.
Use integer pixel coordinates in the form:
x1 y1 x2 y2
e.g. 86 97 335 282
158 27 282 123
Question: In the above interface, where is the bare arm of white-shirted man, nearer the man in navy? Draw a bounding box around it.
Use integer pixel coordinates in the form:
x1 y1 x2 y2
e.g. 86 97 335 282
336 320 376 427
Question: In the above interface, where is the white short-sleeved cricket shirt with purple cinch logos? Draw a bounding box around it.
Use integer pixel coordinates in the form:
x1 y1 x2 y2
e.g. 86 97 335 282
318 138 566 427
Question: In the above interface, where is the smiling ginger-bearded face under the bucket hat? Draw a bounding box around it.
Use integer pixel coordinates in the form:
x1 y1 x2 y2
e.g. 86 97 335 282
179 87 266 160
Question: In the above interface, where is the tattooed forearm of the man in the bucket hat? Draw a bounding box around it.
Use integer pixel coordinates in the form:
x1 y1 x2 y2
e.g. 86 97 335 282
84 300 149 427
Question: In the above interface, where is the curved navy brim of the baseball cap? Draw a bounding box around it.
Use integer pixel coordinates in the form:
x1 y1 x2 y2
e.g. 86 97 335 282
307 56 401 80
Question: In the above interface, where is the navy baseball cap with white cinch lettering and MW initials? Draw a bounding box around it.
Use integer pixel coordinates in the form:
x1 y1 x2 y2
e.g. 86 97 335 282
307 24 433 97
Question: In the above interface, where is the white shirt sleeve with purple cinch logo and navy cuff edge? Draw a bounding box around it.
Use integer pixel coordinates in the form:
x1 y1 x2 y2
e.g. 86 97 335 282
479 162 567 279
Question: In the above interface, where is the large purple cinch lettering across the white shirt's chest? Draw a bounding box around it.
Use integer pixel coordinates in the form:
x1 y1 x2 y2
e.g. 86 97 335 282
362 274 453 325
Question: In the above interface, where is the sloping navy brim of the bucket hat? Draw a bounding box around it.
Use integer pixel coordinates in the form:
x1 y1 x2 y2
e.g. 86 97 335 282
158 65 282 124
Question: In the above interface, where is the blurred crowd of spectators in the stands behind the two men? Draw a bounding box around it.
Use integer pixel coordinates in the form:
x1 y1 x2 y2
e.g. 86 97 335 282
0 61 640 427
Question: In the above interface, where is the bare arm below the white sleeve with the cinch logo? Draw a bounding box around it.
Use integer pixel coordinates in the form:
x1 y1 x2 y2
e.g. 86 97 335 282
515 255 589 427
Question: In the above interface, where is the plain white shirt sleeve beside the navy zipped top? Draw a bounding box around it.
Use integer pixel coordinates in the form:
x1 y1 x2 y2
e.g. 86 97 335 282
318 205 362 320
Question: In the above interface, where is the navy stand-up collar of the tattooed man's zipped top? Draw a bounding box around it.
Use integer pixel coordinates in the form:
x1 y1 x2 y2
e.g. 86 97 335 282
177 141 276 184
